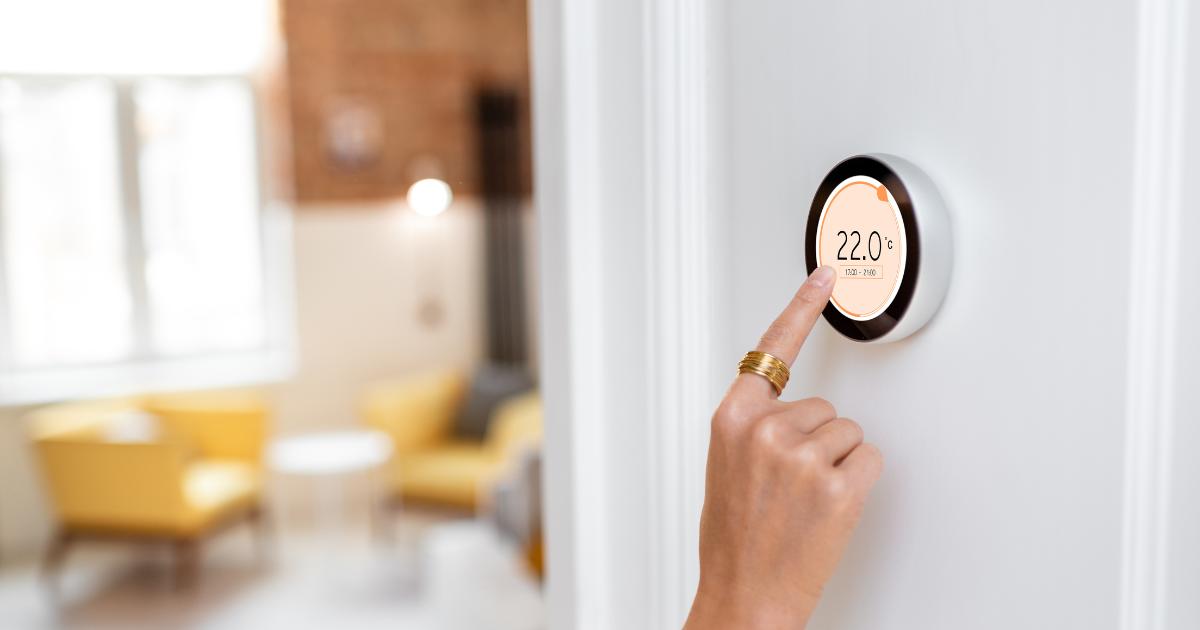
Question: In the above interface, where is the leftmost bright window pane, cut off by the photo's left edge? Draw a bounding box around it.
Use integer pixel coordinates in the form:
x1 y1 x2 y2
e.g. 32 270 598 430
0 80 133 367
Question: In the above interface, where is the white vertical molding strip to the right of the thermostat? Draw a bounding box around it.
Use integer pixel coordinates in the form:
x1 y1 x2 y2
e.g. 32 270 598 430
1121 0 1187 630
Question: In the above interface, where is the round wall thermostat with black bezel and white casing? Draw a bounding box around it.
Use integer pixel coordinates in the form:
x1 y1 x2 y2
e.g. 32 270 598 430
804 154 953 342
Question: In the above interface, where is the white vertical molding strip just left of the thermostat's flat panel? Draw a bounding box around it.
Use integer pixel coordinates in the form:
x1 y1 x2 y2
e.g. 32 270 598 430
643 0 721 628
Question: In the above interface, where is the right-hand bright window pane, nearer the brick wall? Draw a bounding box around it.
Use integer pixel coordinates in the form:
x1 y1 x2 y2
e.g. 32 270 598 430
133 80 266 355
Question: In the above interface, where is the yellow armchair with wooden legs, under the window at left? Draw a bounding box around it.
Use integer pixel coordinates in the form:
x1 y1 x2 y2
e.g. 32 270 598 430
31 392 268 585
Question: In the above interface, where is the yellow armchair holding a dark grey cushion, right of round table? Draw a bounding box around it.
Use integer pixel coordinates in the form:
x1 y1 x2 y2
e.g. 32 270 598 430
362 370 541 510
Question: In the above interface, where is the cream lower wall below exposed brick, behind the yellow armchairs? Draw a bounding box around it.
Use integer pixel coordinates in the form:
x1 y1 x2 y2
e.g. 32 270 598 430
0 203 484 554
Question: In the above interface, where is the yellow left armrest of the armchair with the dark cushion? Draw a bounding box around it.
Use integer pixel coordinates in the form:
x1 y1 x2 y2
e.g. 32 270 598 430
361 370 467 454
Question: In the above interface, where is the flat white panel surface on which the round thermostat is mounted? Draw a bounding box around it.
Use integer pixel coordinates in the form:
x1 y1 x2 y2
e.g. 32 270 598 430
725 0 1139 630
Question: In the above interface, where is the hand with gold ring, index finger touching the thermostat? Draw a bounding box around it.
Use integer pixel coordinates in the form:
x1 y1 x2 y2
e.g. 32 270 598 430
684 266 883 630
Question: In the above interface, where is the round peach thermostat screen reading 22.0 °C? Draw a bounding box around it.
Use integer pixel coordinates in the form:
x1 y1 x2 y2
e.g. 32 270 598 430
816 175 906 322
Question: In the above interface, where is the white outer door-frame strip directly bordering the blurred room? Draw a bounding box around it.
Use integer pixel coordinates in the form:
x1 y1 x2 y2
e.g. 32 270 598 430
530 0 612 630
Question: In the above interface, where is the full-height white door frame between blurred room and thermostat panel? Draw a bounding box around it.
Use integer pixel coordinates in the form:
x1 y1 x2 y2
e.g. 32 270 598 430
530 0 720 629
